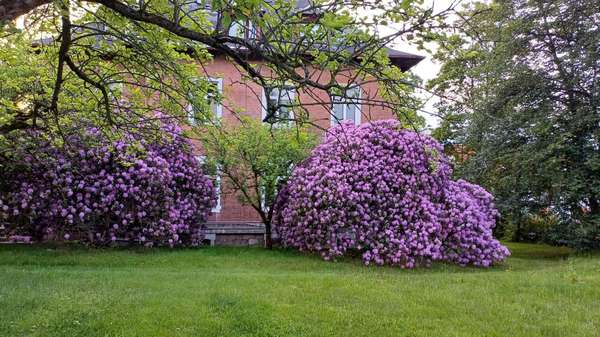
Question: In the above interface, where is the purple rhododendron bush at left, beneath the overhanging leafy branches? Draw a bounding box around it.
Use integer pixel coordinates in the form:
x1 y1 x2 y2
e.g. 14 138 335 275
0 119 216 247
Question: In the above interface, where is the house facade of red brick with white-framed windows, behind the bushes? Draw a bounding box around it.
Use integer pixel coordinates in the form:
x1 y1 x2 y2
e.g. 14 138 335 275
178 0 423 245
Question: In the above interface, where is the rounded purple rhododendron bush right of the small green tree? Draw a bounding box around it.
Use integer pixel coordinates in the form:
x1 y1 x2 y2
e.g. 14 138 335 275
276 120 509 268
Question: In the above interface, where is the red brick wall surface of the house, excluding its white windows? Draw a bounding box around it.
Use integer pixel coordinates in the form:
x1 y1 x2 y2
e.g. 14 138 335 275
201 56 393 223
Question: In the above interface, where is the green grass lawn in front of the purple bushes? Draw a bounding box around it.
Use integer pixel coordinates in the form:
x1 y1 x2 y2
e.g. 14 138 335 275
0 244 600 337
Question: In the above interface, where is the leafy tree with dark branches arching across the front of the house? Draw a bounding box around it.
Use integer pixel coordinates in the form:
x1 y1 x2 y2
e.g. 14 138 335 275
0 0 447 142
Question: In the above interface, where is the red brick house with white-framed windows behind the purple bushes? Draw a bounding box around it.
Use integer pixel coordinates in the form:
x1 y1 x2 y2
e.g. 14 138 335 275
196 53 421 245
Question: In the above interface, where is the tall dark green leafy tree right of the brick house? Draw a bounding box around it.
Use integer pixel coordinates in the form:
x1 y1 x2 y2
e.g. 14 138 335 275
429 0 600 247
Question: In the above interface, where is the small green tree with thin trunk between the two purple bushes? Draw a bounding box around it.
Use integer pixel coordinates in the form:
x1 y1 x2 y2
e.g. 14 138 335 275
202 118 316 248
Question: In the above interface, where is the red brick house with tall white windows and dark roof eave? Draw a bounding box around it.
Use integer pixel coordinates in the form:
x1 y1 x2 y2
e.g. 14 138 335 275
185 0 423 245
